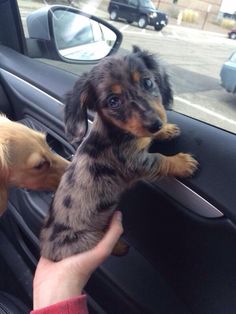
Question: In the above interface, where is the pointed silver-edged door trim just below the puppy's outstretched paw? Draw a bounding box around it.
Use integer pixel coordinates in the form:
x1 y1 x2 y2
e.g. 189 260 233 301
154 178 224 218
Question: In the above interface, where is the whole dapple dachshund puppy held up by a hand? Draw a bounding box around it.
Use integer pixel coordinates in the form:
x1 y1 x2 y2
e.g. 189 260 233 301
41 47 197 261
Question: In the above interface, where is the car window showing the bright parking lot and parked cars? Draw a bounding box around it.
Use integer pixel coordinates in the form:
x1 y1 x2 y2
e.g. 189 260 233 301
18 0 236 133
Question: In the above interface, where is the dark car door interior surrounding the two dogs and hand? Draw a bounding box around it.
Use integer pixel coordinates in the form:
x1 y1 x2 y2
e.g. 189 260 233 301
0 0 236 314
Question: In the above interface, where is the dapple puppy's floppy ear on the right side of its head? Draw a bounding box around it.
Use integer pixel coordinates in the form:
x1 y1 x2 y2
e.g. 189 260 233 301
133 46 173 109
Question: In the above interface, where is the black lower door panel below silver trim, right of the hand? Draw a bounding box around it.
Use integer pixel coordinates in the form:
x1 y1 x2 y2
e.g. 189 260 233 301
119 184 236 314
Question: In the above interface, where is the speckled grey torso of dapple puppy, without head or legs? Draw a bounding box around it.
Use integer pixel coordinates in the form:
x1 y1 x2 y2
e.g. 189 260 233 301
41 121 153 260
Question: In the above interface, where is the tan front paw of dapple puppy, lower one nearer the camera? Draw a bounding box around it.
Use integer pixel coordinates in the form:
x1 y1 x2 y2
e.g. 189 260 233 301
175 153 198 177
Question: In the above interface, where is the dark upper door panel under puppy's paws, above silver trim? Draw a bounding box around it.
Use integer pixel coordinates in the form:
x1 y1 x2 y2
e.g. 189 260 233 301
152 112 236 222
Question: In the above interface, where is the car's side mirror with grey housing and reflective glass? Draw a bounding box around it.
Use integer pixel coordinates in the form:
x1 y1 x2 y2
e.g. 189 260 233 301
27 5 122 63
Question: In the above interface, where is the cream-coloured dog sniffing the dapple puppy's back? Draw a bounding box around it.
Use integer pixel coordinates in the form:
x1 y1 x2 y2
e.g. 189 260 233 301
0 114 69 215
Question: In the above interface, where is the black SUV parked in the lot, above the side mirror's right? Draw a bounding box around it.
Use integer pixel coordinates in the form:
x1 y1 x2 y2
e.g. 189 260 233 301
108 0 168 31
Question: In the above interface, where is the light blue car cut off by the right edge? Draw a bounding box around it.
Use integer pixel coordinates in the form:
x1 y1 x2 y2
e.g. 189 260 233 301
220 52 236 93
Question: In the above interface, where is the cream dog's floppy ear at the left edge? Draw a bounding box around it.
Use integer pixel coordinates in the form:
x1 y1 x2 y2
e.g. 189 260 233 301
0 143 8 216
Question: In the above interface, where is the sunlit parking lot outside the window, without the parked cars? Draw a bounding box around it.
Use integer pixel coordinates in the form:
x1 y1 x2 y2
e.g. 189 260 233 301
18 0 236 133
